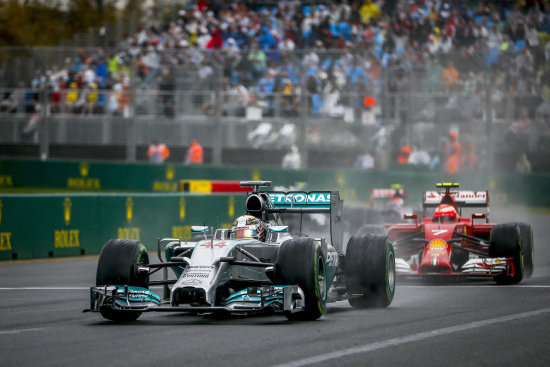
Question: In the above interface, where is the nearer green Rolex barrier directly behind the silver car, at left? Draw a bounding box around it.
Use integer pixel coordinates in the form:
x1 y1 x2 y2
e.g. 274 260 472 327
0 193 245 260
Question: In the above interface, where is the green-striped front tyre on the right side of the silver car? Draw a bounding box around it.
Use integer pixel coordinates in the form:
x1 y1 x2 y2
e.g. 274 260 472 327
275 238 328 320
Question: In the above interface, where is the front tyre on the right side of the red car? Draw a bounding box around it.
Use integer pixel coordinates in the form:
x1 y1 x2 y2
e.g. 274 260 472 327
489 223 524 284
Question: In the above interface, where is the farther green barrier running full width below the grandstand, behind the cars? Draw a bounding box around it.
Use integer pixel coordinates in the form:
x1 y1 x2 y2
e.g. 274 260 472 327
0 159 550 207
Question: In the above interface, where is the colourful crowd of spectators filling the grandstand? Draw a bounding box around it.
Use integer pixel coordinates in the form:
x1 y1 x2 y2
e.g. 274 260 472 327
1 0 550 168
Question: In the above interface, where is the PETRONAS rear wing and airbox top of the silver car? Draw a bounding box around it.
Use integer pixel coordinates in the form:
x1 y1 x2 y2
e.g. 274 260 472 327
241 181 344 252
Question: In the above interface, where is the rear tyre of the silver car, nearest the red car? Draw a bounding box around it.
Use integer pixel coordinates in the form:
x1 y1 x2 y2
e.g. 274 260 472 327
344 234 396 308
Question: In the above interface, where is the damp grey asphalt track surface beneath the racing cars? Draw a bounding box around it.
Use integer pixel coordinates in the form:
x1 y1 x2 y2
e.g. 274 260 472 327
0 210 550 367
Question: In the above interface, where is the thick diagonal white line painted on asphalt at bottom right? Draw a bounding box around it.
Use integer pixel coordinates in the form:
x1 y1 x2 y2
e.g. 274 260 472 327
273 308 550 367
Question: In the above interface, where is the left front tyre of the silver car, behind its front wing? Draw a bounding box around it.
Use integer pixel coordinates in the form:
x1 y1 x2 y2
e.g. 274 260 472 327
96 239 149 322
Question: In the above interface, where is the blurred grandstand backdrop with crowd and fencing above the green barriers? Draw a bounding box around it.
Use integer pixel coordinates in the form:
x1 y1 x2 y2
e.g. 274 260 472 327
0 0 550 175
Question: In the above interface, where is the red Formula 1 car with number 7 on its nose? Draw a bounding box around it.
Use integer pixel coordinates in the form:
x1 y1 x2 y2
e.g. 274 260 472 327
386 183 533 284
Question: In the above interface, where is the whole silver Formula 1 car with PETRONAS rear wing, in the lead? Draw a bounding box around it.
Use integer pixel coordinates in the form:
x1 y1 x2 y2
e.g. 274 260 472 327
85 181 395 321
